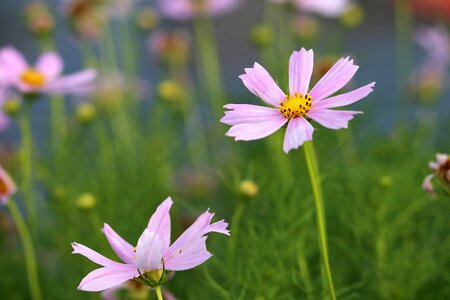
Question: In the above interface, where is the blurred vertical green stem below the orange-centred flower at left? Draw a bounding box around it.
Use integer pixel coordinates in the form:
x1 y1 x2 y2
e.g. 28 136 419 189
19 100 36 224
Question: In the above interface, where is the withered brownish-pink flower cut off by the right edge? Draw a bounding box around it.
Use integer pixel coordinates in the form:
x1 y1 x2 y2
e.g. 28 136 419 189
422 153 450 195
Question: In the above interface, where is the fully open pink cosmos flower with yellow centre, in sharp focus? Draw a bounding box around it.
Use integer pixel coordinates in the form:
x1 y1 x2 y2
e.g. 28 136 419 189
220 48 375 153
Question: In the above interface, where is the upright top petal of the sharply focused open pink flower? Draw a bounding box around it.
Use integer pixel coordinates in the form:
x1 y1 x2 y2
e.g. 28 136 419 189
289 48 314 95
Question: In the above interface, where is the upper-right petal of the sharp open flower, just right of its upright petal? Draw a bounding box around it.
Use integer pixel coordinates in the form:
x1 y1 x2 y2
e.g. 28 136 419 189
309 57 359 101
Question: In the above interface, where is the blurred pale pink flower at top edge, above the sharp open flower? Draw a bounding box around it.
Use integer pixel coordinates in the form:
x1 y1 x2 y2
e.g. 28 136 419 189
270 0 351 18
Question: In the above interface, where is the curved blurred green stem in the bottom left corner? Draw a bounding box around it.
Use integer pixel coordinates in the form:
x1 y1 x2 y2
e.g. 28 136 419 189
8 199 42 300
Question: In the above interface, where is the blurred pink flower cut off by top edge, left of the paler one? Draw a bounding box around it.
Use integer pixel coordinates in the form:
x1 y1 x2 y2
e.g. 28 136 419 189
158 0 243 20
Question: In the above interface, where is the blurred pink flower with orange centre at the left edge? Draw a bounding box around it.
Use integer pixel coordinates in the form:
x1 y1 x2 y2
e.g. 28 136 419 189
0 47 96 94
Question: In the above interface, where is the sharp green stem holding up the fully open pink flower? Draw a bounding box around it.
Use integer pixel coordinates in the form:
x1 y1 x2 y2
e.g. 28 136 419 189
303 142 336 300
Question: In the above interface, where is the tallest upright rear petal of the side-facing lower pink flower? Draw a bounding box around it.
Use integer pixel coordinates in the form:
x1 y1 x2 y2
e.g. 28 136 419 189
147 197 173 252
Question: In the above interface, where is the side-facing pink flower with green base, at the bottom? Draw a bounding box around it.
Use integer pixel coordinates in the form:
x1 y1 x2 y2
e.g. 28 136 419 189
72 197 230 292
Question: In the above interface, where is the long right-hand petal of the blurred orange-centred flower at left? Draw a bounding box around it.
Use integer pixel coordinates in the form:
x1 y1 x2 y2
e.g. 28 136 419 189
42 69 97 94
